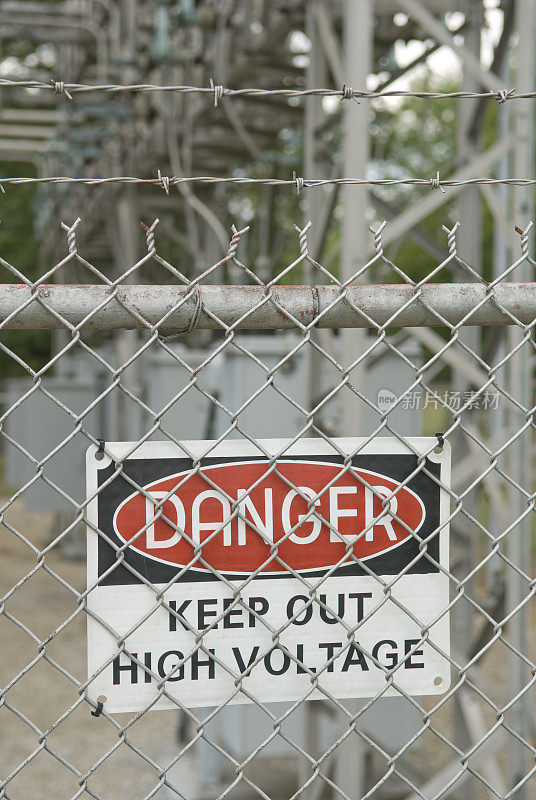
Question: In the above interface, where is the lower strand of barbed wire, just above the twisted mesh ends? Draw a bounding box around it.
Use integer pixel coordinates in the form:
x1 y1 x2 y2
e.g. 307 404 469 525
0 171 536 194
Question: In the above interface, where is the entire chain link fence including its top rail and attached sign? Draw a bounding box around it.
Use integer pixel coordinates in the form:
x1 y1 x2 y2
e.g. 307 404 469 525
0 214 536 800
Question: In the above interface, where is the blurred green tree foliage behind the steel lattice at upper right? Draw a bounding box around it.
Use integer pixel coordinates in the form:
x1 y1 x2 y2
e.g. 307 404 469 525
237 72 497 283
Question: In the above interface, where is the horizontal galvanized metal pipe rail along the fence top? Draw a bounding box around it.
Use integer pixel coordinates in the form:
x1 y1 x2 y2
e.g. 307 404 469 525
0 283 536 332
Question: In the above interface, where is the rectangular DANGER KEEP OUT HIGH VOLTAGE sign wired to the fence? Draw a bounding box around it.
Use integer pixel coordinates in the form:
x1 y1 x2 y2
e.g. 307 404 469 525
87 438 450 711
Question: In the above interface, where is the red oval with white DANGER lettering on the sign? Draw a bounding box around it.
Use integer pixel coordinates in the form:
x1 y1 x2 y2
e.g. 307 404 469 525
114 460 425 574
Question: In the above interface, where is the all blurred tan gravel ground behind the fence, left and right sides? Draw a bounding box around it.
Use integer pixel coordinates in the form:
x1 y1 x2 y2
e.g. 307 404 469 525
0 501 536 800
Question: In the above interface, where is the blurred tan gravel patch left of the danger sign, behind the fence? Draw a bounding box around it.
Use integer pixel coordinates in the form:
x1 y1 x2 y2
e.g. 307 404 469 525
0 505 193 800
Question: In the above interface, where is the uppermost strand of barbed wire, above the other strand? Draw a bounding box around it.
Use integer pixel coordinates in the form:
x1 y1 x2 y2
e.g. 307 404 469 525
0 78 536 106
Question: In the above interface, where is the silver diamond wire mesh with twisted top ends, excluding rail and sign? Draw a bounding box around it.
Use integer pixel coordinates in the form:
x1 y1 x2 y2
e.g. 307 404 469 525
0 216 536 800
